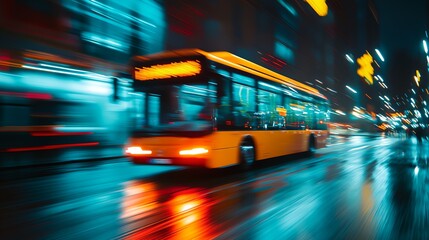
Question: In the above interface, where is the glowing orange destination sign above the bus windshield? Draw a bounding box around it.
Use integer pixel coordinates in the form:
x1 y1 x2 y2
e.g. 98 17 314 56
134 60 201 81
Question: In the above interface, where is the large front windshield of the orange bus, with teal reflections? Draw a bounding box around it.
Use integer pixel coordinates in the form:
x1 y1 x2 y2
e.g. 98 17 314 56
133 82 216 136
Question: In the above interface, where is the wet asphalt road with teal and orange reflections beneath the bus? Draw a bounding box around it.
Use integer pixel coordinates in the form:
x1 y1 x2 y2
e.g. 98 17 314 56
0 136 429 239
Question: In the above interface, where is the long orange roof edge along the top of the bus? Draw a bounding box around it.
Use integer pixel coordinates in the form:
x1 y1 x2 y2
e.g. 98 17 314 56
135 49 327 100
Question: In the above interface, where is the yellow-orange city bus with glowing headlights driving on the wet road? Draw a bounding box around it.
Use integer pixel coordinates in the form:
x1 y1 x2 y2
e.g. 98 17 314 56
125 49 329 169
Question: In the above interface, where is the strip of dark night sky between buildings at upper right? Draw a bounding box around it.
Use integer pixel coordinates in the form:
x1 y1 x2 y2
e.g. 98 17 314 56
377 0 428 94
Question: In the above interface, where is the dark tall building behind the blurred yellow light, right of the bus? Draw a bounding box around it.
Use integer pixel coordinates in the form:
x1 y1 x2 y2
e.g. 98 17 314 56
327 0 385 129
